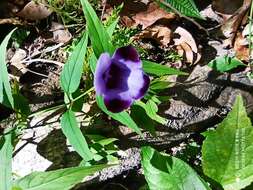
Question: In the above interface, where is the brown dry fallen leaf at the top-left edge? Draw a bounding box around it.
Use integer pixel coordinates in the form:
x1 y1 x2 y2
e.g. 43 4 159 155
17 1 52 21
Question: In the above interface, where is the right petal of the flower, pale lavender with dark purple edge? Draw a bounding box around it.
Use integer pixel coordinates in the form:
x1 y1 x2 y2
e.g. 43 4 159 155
128 69 150 100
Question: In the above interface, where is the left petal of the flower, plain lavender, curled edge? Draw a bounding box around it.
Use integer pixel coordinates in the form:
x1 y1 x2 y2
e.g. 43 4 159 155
94 53 112 95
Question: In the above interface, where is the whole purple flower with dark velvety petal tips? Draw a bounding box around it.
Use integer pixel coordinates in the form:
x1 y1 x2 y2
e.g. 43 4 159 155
94 46 150 113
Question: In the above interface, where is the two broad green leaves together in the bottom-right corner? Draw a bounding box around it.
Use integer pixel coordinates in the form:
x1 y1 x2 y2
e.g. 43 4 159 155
142 96 253 190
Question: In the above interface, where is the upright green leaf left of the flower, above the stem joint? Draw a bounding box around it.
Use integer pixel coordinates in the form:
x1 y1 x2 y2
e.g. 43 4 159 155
60 32 88 94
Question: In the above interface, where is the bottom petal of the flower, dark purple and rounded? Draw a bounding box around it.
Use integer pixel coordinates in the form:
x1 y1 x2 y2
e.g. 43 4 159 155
104 93 133 113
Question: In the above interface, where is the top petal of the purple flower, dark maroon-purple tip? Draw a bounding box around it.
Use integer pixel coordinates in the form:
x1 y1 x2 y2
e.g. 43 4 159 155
112 45 142 68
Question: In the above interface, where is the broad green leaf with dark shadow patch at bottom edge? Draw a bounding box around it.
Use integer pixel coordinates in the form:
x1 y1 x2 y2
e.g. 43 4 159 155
141 147 211 190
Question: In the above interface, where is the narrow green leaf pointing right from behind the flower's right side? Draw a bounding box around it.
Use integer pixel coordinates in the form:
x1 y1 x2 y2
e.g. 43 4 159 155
142 61 188 76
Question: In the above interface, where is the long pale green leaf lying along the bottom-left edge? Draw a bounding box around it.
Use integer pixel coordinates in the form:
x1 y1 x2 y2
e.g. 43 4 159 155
14 165 110 190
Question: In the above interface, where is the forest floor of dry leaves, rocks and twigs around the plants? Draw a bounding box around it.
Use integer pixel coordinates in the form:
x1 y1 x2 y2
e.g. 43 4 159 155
0 0 253 190
